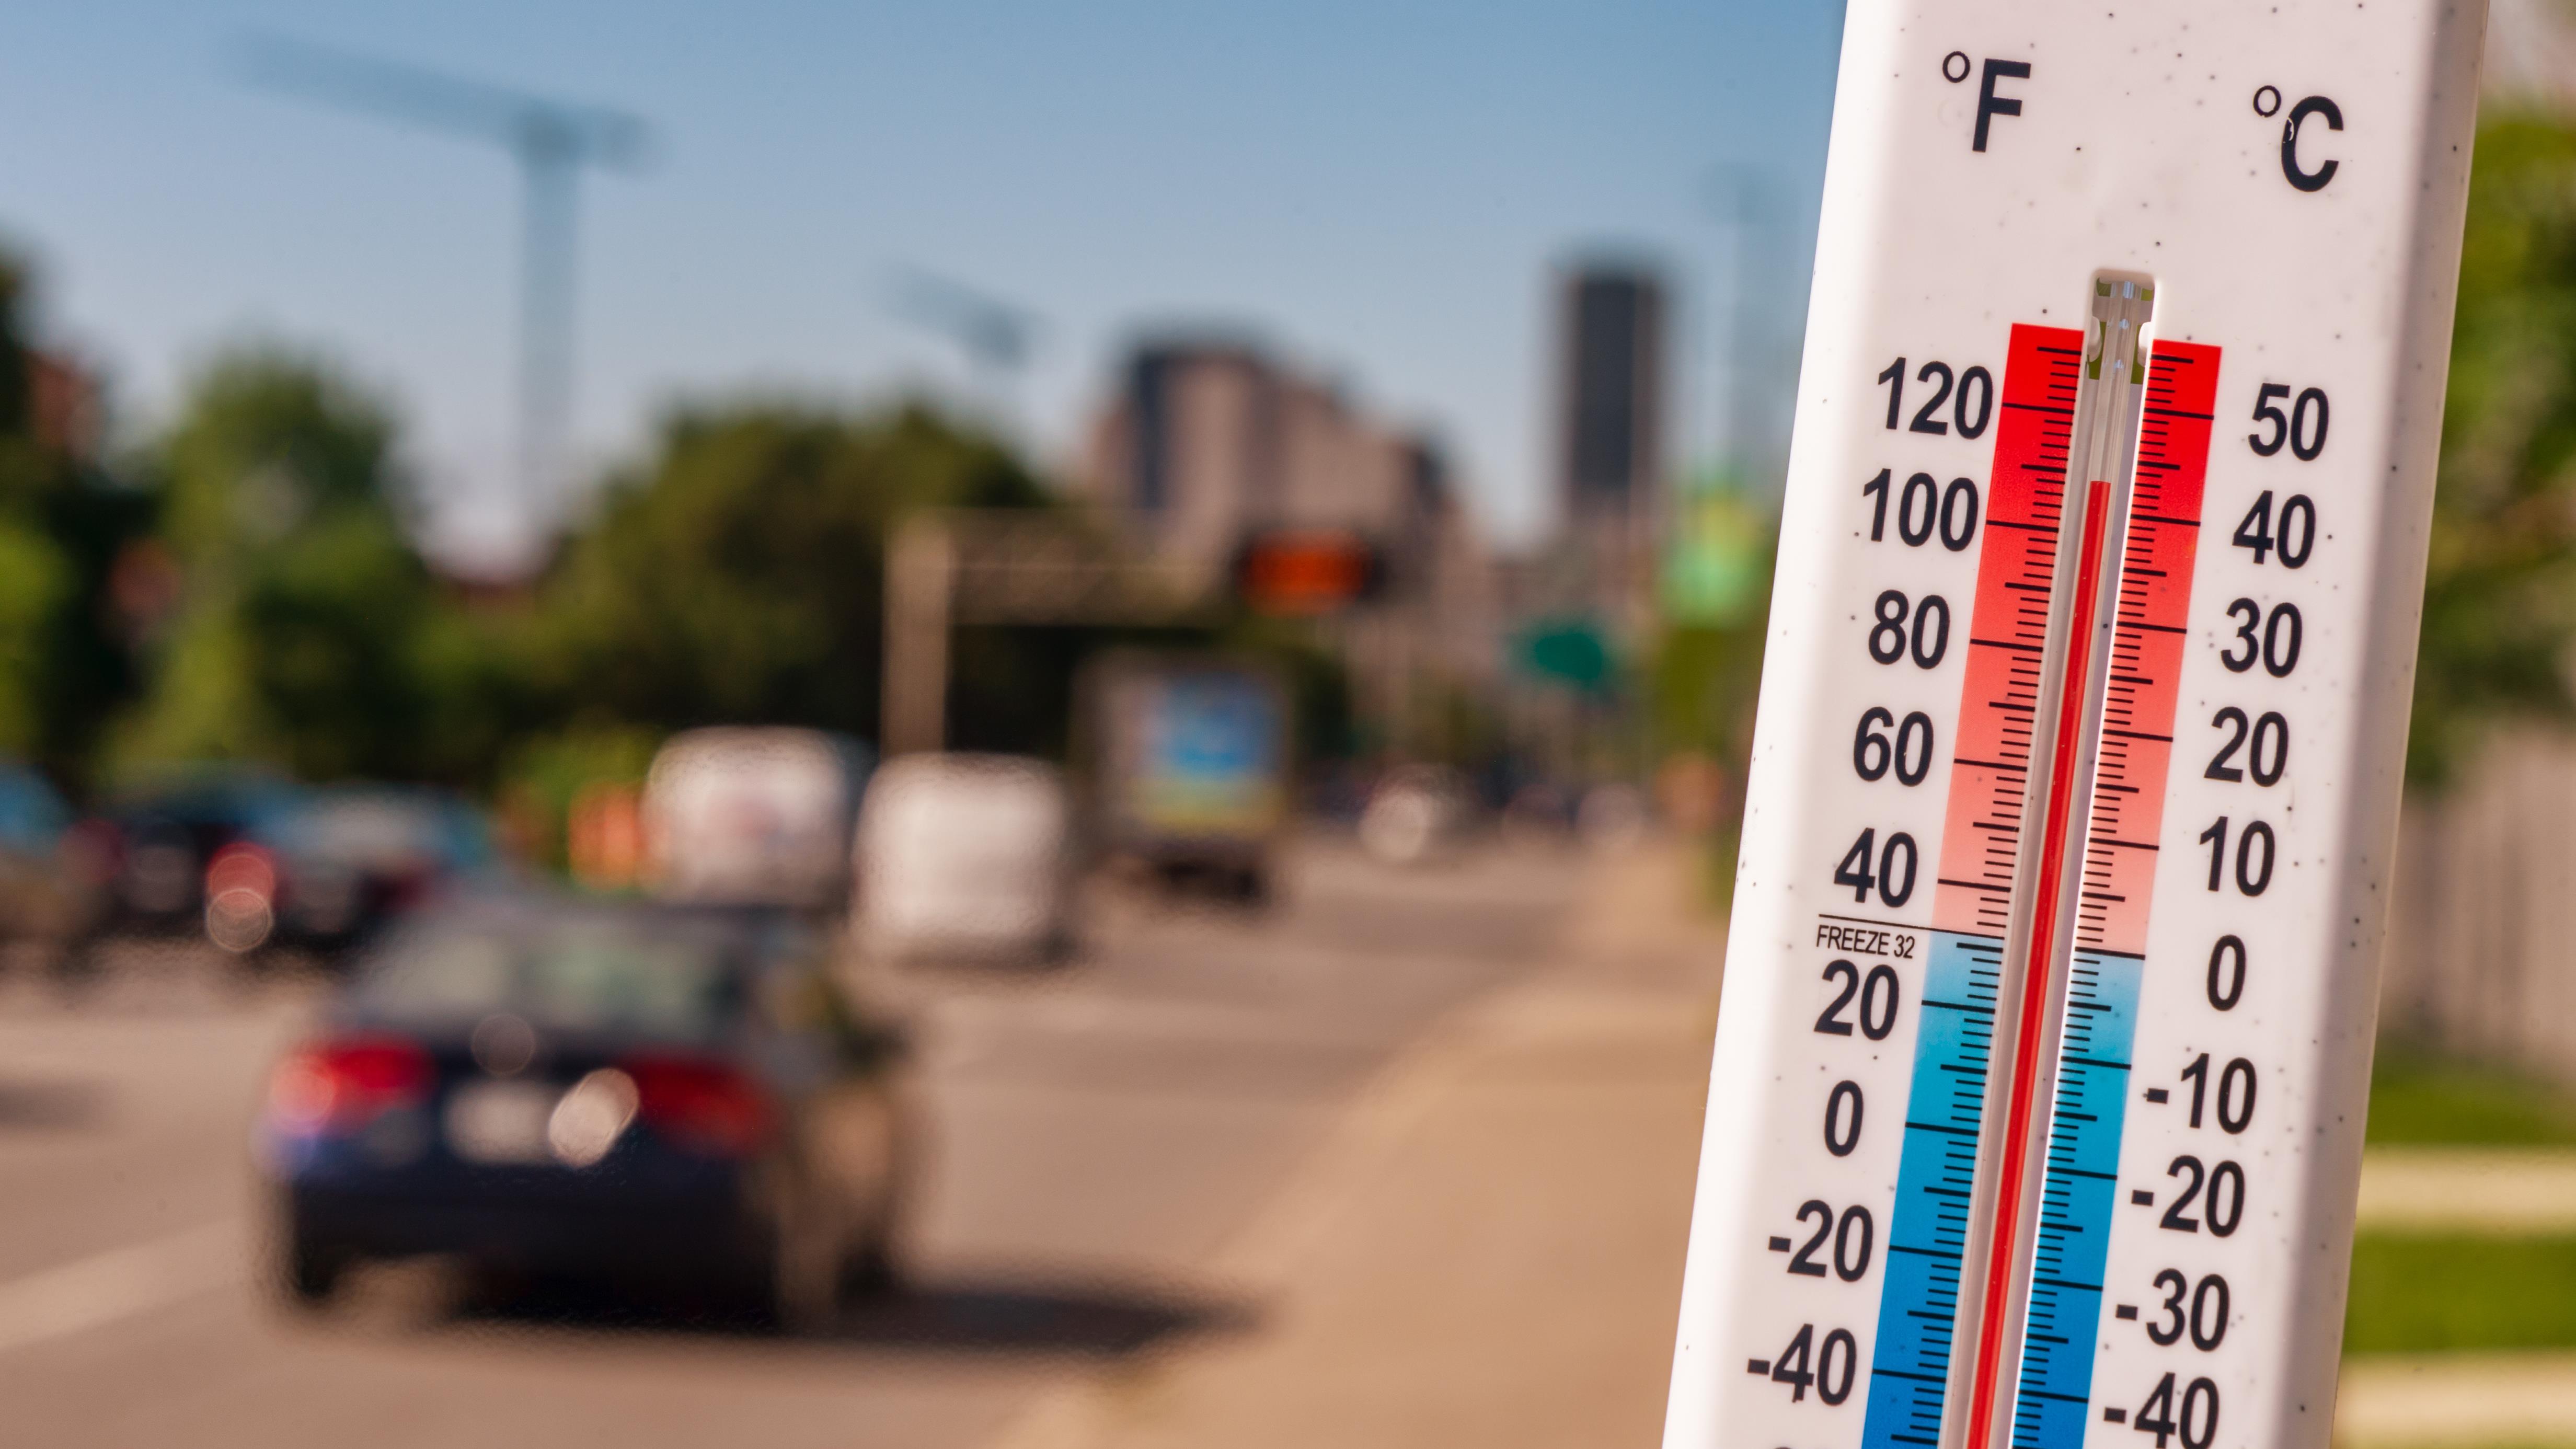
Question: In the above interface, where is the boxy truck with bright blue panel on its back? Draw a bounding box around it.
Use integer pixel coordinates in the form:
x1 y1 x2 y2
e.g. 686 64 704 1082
1082 650 1291 902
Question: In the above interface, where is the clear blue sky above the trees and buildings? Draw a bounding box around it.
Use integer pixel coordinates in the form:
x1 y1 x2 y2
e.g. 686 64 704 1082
0 0 1839 565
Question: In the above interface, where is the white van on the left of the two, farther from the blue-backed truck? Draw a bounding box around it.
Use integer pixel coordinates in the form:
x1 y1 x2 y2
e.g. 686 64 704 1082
641 727 871 915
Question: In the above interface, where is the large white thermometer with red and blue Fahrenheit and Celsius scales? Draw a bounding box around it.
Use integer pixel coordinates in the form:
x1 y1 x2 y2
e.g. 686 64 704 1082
1664 0 2486 1449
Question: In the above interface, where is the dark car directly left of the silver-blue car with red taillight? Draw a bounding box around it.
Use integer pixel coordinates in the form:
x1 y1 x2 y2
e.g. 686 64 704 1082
80 771 302 936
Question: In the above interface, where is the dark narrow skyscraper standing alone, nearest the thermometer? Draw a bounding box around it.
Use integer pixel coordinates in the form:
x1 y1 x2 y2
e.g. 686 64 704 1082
1558 263 1664 521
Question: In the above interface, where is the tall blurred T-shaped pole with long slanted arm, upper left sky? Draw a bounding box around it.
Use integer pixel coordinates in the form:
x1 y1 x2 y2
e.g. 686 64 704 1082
242 36 652 523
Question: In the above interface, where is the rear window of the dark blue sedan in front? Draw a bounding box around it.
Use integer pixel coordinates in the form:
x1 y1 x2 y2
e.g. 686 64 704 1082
355 921 734 1039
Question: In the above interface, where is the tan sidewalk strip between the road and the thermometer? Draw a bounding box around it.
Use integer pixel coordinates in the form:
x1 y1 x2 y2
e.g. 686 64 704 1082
999 846 1723 1449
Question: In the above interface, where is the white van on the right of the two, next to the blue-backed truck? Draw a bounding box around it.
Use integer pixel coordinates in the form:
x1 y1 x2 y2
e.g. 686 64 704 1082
858 755 1074 959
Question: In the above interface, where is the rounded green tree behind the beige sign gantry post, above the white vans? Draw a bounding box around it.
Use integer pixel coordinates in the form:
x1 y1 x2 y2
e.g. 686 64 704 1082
538 405 1074 748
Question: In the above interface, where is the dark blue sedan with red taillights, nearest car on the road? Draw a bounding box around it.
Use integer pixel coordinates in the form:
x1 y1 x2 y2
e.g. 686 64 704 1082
258 895 912 1325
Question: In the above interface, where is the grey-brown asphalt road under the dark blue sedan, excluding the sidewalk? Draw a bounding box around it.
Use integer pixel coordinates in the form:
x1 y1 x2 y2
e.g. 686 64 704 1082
0 846 1574 1449
